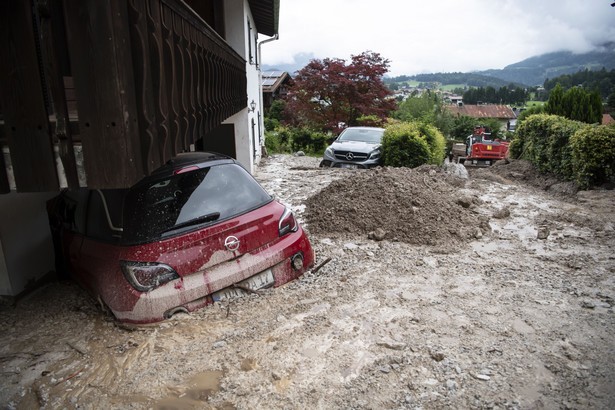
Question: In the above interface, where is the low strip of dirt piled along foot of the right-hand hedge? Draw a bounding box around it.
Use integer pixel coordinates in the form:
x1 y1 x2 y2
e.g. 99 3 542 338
470 159 579 197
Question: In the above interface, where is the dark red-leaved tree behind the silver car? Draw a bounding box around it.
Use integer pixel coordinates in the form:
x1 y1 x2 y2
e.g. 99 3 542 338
284 51 397 134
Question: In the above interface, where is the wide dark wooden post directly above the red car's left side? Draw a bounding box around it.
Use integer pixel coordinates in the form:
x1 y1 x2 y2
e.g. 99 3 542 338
64 0 147 188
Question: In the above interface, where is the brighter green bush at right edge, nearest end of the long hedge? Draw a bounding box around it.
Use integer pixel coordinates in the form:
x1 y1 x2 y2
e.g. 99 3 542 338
570 124 615 188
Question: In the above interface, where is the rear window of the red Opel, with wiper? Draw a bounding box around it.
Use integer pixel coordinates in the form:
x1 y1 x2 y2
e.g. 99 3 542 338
122 164 272 244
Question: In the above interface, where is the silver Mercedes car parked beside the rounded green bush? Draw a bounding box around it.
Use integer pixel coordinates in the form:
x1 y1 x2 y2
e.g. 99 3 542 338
320 127 384 168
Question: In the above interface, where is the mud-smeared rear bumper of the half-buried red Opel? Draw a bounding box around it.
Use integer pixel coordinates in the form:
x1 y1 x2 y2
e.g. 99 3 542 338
107 228 314 324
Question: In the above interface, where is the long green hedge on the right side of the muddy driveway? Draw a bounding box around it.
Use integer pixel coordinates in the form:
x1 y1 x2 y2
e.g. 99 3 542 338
509 114 615 188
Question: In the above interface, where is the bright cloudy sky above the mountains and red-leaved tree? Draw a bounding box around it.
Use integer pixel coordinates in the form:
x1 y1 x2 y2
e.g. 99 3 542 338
259 0 615 77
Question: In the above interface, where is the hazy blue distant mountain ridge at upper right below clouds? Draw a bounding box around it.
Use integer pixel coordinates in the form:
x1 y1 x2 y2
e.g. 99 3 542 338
474 42 615 86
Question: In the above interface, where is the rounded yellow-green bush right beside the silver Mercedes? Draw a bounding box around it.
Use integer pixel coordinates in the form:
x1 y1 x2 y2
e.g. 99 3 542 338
380 122 446 168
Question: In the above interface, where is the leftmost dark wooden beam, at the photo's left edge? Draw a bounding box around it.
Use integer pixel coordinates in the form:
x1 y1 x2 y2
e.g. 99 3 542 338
0 0 59 192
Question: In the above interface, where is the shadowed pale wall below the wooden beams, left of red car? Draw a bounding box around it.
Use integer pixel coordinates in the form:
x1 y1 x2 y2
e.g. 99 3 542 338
0 192 57 296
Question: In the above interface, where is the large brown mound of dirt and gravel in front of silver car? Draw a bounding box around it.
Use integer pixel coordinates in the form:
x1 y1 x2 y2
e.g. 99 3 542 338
305 167 489 247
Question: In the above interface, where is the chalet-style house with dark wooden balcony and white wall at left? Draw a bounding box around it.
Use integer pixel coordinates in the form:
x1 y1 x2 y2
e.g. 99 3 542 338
0 0 279 297
